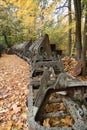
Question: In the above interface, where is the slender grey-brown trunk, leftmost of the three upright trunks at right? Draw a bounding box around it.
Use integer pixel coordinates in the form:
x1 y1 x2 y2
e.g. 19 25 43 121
68 0 72 56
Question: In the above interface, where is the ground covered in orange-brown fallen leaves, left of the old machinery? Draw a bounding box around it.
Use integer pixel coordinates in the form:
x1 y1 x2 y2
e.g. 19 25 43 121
0 54 29 130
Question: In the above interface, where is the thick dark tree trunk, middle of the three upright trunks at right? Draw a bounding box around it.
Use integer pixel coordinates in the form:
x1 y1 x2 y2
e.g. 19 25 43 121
74 0 82 58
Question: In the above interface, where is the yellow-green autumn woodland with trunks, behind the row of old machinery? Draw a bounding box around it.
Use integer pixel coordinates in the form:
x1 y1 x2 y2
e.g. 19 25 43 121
0 0 87 75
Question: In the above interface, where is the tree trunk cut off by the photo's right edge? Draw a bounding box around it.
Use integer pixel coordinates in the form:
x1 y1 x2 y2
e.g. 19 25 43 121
82 5 87 76
